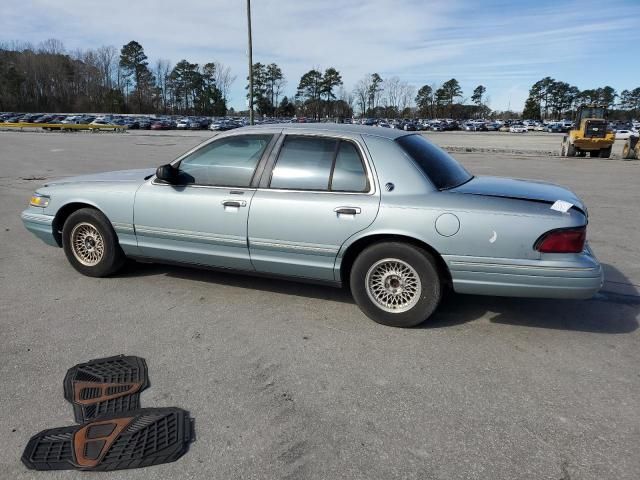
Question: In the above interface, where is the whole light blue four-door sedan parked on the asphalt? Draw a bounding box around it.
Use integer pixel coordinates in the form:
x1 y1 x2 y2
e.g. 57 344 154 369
22 124 603 327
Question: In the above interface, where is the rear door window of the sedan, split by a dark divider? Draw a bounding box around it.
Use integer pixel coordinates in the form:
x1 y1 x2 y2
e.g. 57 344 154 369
270 135 369 192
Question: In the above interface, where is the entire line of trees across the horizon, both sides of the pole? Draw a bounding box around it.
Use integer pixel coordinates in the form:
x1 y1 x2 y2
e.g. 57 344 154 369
0 39 640 120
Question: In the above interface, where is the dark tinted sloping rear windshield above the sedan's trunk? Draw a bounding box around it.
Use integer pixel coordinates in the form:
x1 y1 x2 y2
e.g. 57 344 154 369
396 135 473 190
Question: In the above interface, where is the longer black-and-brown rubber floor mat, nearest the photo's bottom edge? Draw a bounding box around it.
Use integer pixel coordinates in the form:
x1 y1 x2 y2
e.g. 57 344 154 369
22 407 195 471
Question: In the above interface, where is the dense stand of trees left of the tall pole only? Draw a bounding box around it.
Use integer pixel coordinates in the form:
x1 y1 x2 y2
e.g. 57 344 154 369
0 39 235 115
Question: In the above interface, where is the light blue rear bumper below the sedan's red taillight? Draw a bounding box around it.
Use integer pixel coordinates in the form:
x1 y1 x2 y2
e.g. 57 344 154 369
443 247 604 299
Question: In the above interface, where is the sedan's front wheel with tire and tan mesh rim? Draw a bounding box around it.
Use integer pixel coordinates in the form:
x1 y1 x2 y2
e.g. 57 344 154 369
62 208 125 277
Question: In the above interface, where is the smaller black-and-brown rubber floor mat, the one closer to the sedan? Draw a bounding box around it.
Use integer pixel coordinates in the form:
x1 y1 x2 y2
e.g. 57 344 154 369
64 355 149 423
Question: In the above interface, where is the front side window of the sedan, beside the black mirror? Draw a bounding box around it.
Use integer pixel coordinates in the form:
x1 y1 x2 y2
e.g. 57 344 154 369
180 135 272 187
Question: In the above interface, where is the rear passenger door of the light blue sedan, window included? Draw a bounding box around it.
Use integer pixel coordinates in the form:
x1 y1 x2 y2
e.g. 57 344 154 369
249 134 380 281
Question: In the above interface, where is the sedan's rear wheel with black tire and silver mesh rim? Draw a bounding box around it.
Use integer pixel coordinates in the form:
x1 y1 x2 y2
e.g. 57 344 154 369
349 242 442 327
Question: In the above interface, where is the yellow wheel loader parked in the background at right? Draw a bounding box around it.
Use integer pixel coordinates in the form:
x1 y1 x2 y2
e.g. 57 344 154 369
560 105 616 158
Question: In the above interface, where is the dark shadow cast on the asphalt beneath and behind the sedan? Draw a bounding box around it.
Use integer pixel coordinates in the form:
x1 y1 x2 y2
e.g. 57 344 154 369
117 262 640 334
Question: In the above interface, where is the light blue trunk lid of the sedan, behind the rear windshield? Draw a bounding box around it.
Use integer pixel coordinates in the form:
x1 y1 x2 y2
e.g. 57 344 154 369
449 177 586 214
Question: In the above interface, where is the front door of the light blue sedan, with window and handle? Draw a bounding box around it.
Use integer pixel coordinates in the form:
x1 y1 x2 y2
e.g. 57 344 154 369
134 134 273 270
